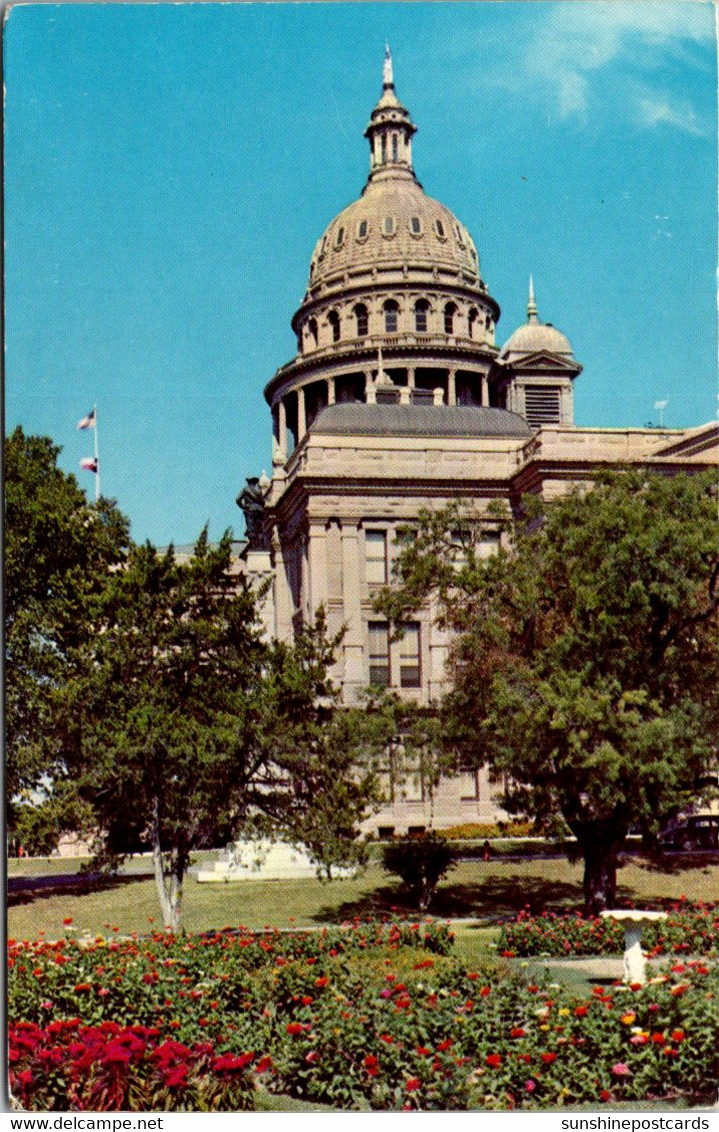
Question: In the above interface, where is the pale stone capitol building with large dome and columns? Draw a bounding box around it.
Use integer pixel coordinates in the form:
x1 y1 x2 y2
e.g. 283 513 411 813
238 50 719 833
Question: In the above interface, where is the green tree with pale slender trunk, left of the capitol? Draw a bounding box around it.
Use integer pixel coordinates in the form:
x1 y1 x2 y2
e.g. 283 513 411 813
63 532 382 931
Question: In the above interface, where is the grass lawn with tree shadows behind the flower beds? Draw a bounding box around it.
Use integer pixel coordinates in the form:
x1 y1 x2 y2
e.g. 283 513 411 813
8 855 719 941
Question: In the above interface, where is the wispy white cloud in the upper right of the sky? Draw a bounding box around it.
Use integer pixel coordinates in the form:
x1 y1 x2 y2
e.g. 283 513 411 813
511 0 714 135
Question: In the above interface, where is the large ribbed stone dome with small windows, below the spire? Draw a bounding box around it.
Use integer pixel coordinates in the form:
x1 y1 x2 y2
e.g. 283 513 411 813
309 176 480 292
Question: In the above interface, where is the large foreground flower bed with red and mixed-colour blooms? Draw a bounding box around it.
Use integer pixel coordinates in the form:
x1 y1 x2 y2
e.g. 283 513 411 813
9 924 719 1110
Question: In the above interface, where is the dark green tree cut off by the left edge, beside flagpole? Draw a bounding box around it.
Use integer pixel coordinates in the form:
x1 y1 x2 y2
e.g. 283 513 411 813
5 427 129 825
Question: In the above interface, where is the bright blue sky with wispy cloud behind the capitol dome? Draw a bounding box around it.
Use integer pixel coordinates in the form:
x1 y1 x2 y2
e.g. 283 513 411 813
5 0 717 544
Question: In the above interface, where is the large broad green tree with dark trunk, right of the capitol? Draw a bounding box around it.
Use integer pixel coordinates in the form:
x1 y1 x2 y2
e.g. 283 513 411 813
379 471 719 912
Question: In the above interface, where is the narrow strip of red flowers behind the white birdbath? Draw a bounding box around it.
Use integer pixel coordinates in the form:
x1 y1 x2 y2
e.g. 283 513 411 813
498 901 719 958
